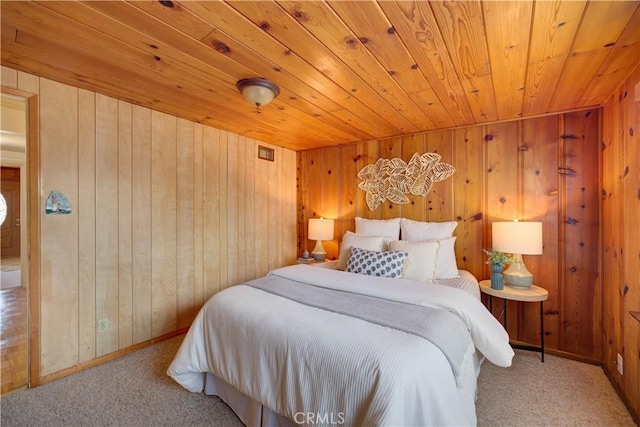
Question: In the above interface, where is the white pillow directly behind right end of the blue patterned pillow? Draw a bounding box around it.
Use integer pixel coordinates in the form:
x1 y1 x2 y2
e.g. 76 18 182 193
389 240 440 282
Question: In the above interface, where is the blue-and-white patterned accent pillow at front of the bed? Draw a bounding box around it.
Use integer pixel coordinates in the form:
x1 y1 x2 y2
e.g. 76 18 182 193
345 247 409 278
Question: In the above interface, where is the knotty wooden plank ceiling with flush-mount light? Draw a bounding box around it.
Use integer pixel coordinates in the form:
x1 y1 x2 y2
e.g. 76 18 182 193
1 0 640 150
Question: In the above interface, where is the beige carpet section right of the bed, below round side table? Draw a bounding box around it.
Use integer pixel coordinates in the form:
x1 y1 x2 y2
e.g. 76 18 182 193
476 350 636 427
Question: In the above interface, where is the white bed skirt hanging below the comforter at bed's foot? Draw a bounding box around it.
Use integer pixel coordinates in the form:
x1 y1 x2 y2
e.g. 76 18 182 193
204 373 296 427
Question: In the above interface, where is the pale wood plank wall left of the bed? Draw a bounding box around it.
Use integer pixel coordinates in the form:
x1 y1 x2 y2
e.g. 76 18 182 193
2 67 296 377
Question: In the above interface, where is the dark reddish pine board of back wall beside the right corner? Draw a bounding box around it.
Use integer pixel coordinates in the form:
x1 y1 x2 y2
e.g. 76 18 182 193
560 110 602 359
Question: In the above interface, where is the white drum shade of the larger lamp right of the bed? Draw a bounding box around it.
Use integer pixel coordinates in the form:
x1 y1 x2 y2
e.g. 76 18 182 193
491 221 542 255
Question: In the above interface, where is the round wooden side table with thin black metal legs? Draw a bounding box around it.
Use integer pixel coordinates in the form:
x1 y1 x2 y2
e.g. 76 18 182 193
480 280 549 362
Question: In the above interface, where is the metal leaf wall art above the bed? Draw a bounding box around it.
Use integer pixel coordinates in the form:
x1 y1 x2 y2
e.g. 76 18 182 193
358 153 456 211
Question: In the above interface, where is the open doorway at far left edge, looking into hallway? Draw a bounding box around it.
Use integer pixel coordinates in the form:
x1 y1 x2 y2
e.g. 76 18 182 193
0 92 29 394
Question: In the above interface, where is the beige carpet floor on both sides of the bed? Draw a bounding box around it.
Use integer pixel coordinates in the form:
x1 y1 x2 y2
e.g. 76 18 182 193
0 336 636 427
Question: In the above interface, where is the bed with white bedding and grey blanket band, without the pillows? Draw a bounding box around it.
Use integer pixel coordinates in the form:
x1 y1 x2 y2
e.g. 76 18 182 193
167 219 514 426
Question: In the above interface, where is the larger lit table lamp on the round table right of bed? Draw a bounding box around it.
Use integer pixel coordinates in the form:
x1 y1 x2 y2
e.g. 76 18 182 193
491 220 542 289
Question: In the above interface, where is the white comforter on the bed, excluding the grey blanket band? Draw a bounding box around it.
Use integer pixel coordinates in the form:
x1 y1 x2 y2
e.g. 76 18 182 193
167 265 514 425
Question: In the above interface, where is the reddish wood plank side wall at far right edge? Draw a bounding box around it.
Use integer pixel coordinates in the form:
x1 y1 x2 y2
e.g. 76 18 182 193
602 63 640 421
